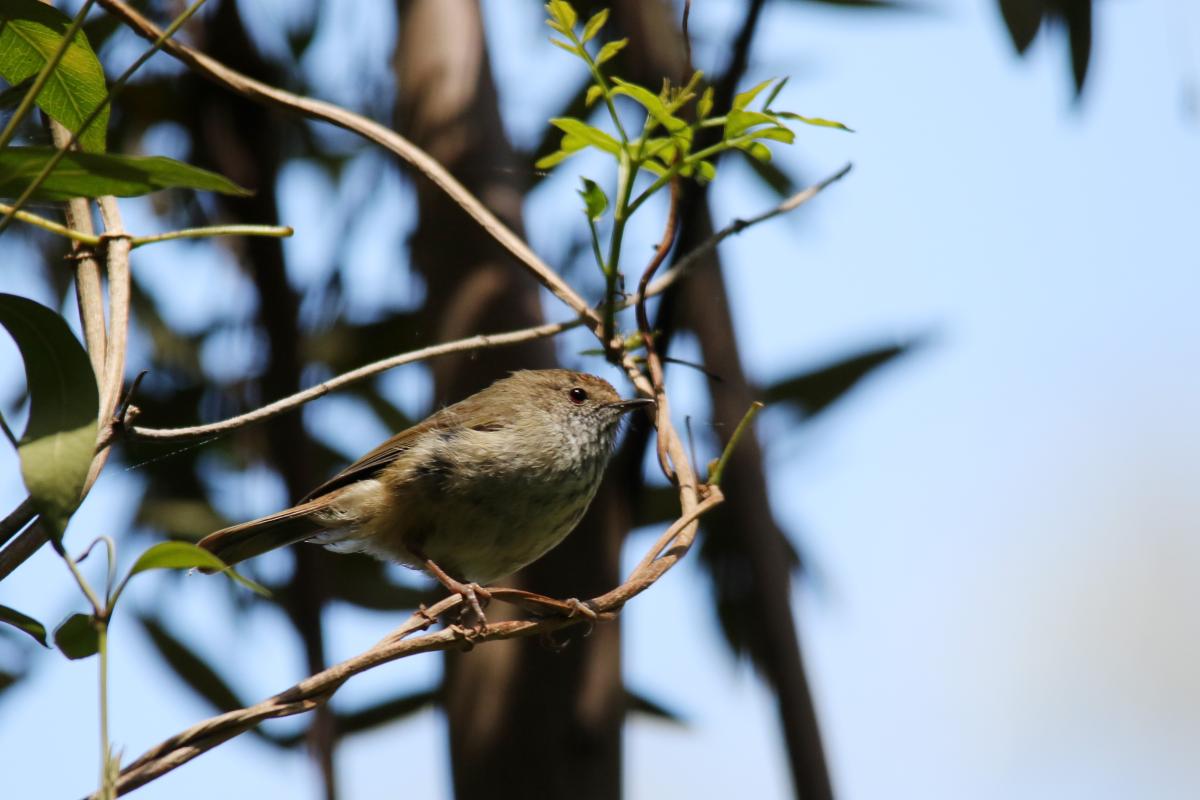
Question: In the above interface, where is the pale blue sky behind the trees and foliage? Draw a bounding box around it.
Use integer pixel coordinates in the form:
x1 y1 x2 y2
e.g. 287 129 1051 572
0 0 1200 800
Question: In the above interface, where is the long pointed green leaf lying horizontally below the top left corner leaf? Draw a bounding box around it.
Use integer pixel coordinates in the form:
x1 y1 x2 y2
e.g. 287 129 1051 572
0 148 251 200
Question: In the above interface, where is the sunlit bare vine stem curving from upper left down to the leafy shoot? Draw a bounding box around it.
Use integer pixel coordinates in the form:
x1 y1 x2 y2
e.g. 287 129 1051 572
93 0 600 327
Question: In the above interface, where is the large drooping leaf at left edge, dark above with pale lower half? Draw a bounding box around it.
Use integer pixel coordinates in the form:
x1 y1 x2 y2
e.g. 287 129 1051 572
0 294 100 537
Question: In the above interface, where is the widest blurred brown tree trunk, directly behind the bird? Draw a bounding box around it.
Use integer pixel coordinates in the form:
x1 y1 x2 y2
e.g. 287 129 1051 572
396 0 629 800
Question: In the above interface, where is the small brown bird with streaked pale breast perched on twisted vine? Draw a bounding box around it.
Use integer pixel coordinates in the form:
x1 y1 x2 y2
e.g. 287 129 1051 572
199 369 654 624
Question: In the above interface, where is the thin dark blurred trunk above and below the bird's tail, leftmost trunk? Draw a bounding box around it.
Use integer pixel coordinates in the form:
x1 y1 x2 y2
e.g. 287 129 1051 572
184 0 337 800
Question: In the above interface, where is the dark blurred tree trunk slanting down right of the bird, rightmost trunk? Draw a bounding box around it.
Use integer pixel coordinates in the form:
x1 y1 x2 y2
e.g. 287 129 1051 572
613 0 833 800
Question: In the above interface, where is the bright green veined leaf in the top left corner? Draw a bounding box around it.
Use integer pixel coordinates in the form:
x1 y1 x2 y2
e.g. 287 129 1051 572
0 0 108 152
